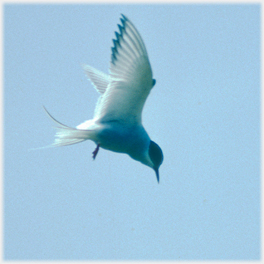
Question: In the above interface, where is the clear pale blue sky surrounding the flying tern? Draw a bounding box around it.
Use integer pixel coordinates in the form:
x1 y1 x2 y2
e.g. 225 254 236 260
4 4 260 260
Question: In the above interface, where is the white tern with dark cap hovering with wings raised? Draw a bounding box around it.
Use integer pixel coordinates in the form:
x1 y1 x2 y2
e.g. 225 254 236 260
44 15 163 182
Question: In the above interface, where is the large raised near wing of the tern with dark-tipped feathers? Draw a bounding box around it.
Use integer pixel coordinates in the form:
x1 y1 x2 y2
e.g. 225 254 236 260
95 15 155 123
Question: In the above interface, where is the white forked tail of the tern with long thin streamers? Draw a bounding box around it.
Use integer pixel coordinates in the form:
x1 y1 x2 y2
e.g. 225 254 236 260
43 106 92 147
